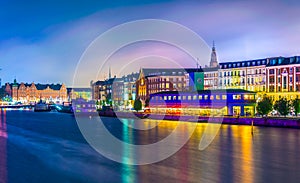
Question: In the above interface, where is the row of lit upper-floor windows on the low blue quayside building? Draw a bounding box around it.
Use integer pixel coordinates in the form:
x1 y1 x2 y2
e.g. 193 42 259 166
151 94 255 101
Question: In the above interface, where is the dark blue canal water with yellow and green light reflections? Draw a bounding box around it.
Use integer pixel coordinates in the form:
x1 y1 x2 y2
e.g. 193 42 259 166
0 110 300 183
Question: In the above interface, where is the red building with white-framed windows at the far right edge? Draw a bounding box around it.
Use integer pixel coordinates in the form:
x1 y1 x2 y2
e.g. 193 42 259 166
266 56 300 100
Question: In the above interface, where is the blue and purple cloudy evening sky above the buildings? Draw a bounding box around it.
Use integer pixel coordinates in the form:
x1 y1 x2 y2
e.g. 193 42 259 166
0 0 300 86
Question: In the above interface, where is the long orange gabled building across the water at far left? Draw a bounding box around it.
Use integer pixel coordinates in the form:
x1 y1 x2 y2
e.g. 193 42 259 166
5 79 68 103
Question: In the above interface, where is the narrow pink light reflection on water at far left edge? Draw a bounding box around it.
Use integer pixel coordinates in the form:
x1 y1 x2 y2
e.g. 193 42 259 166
0 109 7 182
